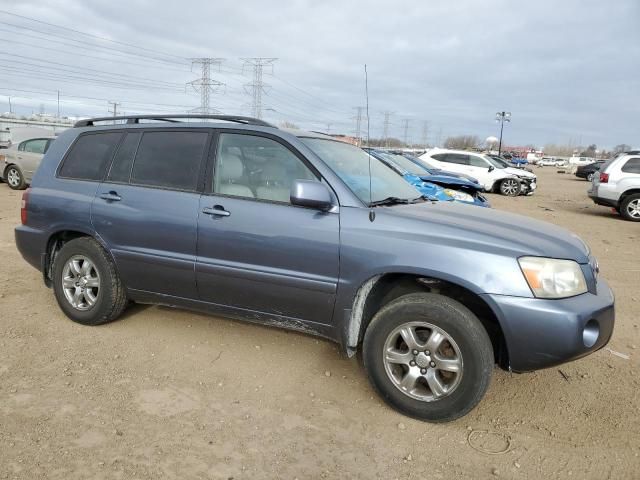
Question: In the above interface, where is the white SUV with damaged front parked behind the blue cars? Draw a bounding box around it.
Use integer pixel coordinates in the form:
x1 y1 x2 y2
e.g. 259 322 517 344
420 148 537 197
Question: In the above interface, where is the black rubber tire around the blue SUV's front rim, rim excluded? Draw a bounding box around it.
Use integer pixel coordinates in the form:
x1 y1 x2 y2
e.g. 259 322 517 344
362 293 494 422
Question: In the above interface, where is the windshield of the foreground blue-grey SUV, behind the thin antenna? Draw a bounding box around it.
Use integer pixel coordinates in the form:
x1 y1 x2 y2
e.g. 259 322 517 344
300 137 420 205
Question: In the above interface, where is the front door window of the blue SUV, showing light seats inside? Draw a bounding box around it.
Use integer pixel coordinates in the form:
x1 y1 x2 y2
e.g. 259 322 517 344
213 133 318 203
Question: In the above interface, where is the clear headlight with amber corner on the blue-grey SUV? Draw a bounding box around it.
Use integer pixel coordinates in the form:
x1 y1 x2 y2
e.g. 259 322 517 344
518 257 587 298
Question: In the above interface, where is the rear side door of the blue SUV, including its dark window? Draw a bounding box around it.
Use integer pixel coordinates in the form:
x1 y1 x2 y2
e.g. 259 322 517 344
92 128 210 299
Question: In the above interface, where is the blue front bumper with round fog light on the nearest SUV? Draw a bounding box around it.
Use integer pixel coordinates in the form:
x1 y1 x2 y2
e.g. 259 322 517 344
482 279 615 372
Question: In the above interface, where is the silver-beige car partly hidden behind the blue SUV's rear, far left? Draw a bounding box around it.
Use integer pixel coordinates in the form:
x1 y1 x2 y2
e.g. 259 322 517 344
0 137 56 190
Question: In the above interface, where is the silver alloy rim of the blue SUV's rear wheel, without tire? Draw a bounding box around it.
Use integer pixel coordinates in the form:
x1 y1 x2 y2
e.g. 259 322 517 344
62 255 100 311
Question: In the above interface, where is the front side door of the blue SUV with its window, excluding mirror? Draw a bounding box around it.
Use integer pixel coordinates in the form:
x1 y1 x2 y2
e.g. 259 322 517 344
196 132 340 326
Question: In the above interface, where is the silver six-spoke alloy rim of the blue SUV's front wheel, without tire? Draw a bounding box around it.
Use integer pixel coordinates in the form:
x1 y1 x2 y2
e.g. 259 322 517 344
383 322 463 402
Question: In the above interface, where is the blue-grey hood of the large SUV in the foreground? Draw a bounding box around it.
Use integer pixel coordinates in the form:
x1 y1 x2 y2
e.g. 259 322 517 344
377 202 589 264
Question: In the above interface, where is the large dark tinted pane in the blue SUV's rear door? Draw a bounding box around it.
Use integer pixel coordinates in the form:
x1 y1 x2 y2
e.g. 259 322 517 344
131 131 209 190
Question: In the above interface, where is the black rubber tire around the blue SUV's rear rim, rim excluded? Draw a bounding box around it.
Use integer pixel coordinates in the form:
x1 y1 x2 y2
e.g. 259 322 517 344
53 237 127 325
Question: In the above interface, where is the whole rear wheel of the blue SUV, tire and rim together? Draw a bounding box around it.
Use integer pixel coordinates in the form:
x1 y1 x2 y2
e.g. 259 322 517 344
53 237 127 325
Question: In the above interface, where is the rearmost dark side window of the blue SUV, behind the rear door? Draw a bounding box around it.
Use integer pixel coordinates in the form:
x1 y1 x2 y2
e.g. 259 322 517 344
60 132 122 180
